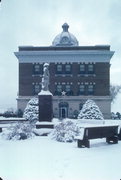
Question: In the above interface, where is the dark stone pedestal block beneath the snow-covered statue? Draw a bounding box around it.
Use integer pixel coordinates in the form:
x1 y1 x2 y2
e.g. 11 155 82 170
38 93 53 122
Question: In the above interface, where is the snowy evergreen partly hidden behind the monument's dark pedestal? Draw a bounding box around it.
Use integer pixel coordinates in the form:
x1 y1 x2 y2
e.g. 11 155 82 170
23 97 39 122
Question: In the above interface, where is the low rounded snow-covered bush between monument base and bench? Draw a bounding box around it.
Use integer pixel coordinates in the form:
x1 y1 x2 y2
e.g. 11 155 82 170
50 120 80 142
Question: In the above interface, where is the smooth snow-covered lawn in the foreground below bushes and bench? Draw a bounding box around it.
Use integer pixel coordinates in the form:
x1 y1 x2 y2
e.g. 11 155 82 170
0 137 121 180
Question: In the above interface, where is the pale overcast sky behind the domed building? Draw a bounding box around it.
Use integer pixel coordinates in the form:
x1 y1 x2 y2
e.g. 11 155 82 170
0 0 121 112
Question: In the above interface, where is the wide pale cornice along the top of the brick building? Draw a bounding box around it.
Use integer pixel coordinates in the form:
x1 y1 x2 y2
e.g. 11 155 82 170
15 50 114 63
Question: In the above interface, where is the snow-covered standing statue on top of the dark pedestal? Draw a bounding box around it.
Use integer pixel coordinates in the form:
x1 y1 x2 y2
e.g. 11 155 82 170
42 63 49 91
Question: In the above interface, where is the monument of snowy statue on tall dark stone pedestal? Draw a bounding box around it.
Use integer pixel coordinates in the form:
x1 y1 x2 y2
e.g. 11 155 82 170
38 63 53 122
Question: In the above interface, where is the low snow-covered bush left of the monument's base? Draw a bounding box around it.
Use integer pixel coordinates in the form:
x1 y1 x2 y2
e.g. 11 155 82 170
2 122 34 140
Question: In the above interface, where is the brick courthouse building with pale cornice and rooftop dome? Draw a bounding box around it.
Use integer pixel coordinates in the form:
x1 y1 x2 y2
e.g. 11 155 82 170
15 23 114 118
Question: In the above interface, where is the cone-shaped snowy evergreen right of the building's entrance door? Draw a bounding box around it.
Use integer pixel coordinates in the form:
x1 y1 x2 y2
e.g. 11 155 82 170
78 99 104 120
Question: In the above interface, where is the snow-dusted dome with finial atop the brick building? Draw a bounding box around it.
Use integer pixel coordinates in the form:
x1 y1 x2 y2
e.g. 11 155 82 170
52 23 79 46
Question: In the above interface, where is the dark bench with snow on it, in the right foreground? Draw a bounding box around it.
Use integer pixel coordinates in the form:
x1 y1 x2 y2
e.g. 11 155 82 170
75 125 118 148
